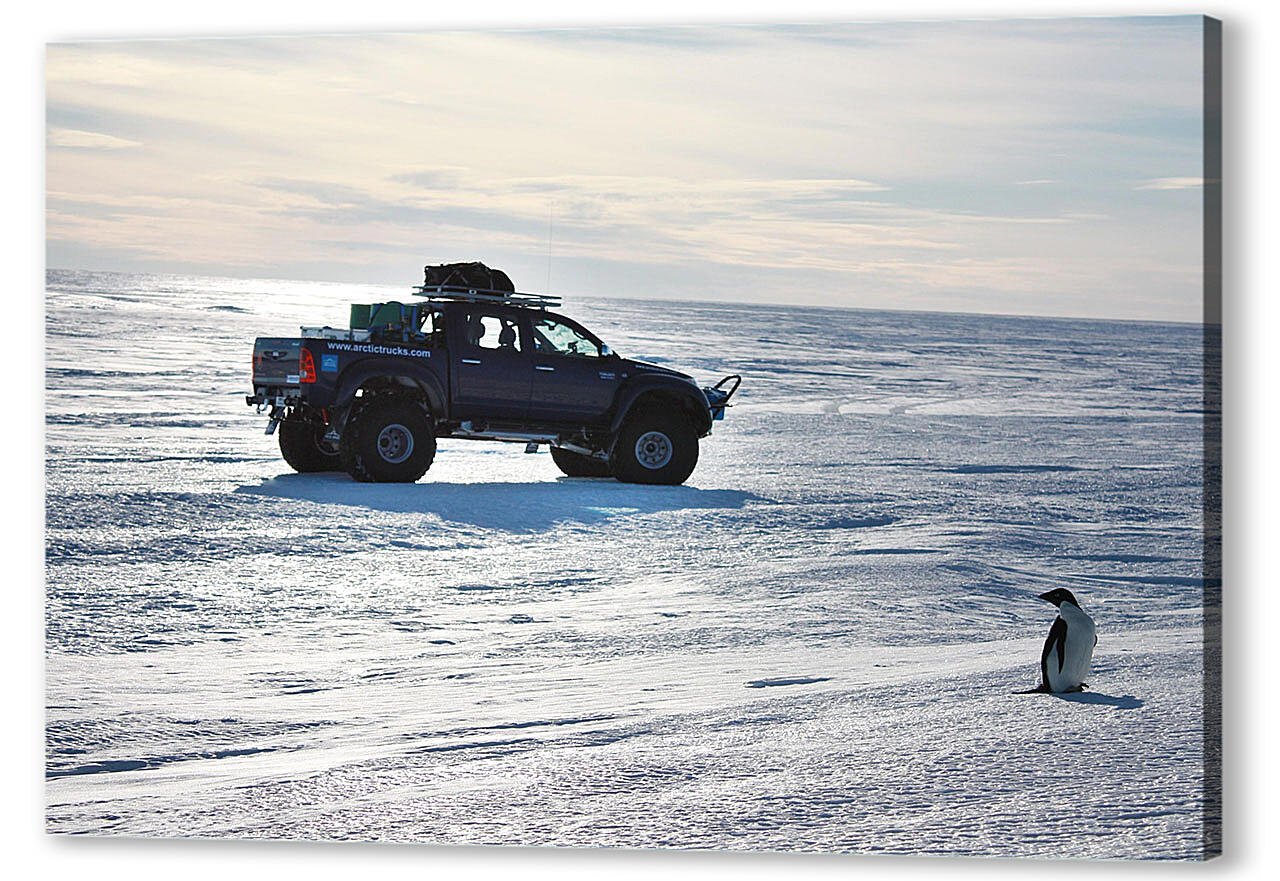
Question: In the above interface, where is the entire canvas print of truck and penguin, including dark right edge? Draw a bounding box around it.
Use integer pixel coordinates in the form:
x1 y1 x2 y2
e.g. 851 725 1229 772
45 15 1221 861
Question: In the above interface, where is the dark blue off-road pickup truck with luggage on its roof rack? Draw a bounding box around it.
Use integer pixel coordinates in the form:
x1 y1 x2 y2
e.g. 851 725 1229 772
246 264 741 484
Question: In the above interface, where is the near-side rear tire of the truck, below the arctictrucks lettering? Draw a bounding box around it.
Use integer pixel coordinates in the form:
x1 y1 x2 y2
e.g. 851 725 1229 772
342 398 435 483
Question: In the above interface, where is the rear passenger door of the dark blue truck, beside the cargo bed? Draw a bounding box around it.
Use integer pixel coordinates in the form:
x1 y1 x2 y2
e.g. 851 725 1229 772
449 303 532 421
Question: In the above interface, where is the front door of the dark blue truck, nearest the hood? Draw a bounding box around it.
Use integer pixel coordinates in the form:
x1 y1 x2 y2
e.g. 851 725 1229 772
529 312 618 423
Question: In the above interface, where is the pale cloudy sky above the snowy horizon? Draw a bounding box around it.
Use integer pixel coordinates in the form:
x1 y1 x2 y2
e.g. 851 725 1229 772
46 15 1203 321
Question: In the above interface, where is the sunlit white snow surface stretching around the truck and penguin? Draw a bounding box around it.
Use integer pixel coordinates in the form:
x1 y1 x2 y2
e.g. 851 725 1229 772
46 271 1213 859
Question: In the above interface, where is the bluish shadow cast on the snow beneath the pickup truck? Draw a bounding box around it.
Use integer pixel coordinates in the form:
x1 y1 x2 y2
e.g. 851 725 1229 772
234 474 771 533
